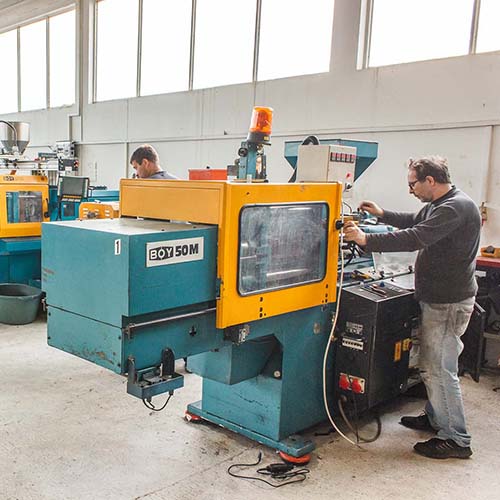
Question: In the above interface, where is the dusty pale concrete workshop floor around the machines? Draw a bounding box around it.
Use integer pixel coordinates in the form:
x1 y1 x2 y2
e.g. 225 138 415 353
0 320 500 500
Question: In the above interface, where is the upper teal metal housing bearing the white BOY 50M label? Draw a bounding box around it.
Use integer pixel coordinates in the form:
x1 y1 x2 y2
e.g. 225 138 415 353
42 218 217 327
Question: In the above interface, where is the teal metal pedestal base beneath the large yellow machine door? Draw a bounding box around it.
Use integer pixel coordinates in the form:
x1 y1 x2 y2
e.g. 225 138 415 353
189 306 333 441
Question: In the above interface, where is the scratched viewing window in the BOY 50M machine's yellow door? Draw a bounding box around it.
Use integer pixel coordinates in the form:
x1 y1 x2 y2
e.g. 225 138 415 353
238 203 328 295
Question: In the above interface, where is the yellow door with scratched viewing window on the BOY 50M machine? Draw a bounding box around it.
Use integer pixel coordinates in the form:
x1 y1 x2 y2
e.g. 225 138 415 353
216 183 342 328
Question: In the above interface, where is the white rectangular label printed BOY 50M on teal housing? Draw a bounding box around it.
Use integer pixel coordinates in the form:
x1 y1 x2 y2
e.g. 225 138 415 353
146 238 204 267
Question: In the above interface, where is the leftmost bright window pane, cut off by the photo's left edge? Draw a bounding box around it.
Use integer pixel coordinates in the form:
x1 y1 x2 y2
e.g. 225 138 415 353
0 30 17 114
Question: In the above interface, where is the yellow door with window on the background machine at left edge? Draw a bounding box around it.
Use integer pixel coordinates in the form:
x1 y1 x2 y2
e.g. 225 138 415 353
0 176 49 238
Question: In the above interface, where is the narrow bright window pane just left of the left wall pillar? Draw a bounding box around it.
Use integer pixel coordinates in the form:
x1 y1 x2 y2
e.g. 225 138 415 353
49 10 76 108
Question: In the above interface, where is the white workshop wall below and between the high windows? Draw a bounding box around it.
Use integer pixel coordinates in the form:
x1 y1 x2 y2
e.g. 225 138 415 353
0 0 500 362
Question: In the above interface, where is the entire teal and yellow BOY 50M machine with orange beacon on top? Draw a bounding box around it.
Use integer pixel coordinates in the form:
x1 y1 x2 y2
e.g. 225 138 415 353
42 108 378 457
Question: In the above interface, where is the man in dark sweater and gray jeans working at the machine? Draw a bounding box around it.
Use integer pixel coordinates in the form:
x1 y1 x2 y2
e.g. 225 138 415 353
344 157 481 458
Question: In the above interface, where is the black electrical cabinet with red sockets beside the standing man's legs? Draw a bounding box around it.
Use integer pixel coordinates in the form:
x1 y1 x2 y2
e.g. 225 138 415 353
334 281 418 413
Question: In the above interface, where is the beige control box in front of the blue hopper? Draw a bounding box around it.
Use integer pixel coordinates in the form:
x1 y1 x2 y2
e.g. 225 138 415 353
297 144 356 196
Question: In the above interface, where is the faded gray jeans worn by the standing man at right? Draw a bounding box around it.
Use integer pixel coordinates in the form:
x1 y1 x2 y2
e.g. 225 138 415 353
419 297 474 446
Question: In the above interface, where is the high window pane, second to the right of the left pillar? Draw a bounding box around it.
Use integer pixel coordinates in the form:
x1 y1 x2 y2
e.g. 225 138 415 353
140 0 192 95
